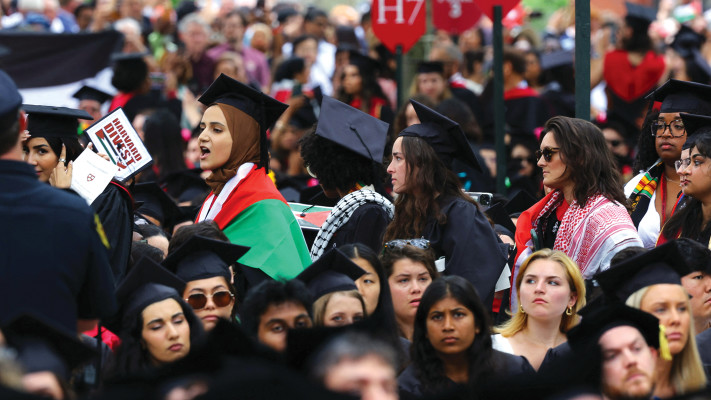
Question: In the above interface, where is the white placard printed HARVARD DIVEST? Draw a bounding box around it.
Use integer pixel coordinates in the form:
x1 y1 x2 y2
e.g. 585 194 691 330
84 107 153 182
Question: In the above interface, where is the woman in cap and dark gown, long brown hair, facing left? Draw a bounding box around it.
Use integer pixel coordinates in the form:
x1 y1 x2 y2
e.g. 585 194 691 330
385 100 508 306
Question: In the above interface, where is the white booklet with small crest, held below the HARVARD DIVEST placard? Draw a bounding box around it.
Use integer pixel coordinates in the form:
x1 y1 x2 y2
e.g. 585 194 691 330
70 149 119 204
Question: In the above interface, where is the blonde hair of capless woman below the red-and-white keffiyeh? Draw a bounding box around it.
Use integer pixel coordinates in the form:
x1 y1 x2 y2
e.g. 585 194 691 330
494 249 585 337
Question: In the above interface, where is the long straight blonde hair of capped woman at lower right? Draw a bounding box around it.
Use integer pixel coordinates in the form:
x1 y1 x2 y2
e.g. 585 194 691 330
625 285 706 395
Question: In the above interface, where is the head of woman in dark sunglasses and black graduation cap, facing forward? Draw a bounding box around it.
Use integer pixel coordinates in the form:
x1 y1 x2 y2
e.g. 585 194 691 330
163 236 249 331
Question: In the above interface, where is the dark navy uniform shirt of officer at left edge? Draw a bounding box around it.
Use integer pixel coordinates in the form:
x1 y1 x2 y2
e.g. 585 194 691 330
0 160 116 331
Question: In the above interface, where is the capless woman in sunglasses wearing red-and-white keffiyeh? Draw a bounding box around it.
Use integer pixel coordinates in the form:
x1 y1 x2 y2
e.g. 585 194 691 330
511 117 642 288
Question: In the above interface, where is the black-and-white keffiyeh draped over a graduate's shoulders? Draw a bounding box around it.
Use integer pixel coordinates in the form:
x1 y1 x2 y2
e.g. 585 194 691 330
311 188 395 261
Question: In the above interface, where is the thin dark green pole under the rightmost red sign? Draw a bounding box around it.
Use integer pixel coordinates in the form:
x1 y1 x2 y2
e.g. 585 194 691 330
494 6 506 195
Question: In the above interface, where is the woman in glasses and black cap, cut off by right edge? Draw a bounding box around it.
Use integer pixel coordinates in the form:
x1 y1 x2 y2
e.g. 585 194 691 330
657 114 711 246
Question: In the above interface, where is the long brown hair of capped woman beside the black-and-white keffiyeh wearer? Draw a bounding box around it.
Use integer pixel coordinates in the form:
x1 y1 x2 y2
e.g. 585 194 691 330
384 136 476 241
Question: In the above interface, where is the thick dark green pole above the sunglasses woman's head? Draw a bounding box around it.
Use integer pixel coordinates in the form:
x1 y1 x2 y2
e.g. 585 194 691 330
575 0 590 121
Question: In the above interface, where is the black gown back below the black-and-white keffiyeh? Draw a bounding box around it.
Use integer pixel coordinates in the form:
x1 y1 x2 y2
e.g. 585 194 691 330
326 203 390 254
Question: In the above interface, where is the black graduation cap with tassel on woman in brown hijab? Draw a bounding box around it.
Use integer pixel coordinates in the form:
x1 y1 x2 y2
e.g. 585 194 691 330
198 74 289 168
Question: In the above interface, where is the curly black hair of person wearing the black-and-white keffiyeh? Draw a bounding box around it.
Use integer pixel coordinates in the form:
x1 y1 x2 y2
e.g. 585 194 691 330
299 131 385 192
